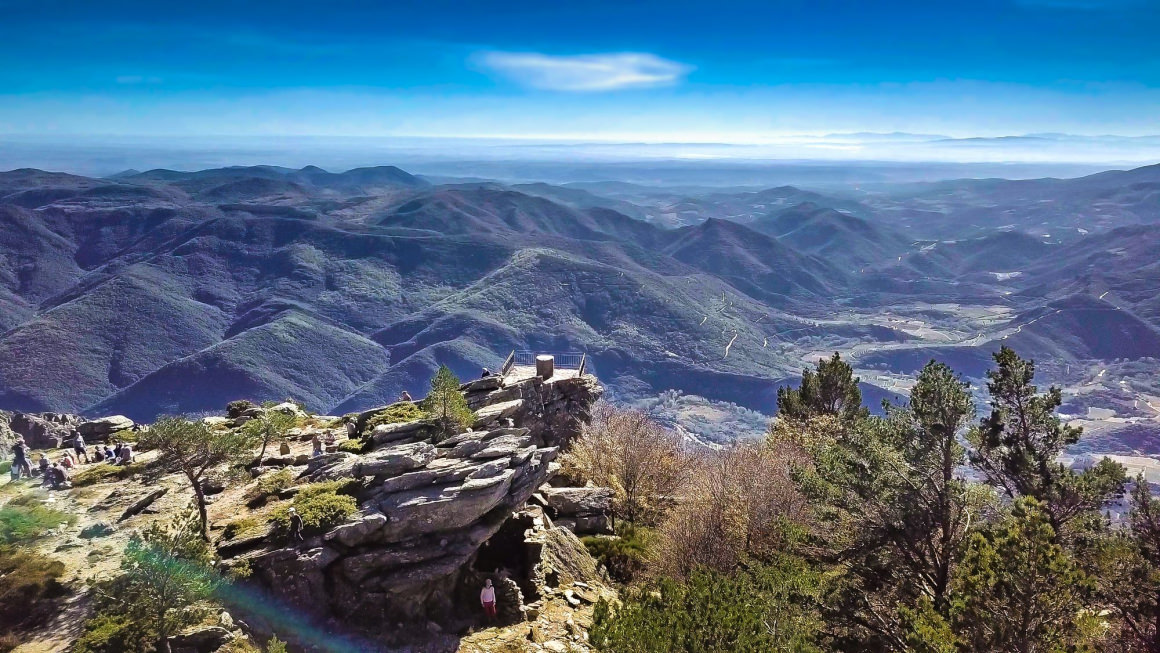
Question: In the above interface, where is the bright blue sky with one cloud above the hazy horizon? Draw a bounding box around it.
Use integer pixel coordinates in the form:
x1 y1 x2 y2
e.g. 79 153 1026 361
0 0 1160 143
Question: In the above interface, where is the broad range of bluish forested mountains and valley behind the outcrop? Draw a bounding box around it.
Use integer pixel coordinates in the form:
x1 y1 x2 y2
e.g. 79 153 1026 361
0 161 1160 436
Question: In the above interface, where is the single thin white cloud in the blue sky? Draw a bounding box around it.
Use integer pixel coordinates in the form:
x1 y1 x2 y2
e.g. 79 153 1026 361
476 52 693 93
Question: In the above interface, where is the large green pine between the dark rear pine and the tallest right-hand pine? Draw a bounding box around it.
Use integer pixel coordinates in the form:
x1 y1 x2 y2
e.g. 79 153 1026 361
778 361 987 650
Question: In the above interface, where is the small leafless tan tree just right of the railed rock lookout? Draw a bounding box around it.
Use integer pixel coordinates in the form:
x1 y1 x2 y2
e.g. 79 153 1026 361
564 404 693 523
